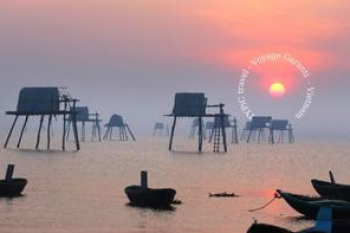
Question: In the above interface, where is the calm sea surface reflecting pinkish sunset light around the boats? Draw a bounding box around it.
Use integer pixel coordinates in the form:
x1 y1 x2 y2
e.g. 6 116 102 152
0 135 350 233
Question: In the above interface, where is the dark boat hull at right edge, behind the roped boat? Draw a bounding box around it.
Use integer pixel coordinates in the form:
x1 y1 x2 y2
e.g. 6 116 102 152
311 179 350 201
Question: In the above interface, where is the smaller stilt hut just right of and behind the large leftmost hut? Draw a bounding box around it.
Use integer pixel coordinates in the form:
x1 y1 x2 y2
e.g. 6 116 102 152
67 106 101 142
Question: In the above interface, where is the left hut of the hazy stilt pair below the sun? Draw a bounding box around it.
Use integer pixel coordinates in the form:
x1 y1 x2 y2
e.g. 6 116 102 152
246 116 274 143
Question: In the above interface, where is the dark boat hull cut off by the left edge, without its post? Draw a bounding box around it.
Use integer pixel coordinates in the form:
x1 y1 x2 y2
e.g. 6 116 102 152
0 178 27 197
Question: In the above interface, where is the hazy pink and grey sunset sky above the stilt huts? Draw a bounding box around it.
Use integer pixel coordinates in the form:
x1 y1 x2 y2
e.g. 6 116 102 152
0 0 350 139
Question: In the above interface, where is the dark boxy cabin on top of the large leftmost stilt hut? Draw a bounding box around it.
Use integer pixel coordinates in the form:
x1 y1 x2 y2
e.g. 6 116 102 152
17 87 60 114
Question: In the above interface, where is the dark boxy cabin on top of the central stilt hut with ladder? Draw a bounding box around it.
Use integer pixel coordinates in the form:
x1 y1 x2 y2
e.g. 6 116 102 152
172 93 207 117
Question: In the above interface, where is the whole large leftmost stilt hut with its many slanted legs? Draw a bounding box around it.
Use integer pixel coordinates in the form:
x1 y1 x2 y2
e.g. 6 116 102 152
4 87 80 150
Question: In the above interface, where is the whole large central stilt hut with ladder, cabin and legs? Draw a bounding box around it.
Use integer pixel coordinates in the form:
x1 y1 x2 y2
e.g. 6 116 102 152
167 93 227 152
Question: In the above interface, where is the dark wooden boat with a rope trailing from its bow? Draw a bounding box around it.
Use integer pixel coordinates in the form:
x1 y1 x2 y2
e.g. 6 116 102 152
277 189 350 219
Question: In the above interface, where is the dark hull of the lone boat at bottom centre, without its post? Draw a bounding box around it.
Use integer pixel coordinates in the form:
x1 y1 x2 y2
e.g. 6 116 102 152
124 185 176 207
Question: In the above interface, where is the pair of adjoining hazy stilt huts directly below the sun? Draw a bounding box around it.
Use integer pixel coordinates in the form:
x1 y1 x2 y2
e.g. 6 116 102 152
241 116 294 144
